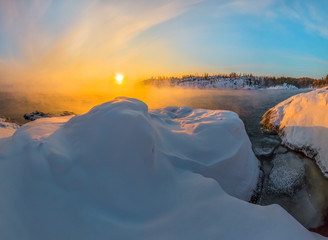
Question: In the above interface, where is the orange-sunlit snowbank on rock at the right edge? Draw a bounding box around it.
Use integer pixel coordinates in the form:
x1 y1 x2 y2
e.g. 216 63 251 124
261 88 328 177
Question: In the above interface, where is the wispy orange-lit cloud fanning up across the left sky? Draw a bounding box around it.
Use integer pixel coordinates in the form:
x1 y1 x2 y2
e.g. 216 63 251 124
0 0 200 92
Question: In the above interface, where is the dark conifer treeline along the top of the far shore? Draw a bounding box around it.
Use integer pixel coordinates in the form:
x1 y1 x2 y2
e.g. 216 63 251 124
143 72 328 88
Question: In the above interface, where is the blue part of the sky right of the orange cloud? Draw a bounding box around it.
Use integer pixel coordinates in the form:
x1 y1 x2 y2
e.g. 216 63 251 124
138 1 328 77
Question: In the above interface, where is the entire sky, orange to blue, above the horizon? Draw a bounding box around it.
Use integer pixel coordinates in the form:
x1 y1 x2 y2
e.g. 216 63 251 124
0 0 328 91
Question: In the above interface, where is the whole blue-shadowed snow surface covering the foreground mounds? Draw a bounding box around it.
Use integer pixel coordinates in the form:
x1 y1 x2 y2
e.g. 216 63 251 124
0 98 321 240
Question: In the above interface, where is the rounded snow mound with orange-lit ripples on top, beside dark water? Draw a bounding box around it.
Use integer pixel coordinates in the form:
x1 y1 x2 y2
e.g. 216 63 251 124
151 107 259 200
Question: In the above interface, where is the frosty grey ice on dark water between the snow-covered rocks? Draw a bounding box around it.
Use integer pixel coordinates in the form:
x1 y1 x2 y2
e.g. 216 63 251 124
257 152 327 229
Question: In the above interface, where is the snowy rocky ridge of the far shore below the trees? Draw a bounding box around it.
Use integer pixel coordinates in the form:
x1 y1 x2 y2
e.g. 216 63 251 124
144 76 298 89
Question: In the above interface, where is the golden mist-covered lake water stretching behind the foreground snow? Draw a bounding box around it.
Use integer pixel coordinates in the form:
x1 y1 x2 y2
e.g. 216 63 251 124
0 87 308 130
